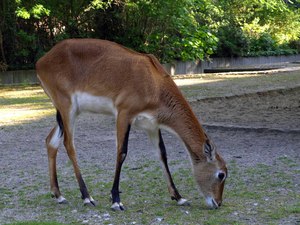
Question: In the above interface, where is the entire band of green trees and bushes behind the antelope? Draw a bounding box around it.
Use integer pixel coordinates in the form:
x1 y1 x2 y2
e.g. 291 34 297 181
0 0 300 69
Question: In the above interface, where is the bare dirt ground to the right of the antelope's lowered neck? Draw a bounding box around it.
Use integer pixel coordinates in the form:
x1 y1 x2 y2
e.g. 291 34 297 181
192 88 300 167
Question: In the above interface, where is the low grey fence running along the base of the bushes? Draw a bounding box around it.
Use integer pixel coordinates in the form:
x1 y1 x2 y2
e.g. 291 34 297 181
0 55 300 85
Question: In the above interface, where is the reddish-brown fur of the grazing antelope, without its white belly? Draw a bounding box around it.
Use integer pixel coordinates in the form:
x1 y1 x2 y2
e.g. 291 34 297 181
36 39 227 209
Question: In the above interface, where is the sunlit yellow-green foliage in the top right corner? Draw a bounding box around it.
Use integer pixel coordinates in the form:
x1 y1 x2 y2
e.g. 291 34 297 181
216 0 300 56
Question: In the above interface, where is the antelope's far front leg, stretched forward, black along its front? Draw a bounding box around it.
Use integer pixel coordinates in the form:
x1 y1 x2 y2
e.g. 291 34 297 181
149 130 189 205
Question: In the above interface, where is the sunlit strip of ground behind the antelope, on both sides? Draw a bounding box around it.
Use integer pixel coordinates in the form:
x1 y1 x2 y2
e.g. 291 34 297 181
0 71 300 126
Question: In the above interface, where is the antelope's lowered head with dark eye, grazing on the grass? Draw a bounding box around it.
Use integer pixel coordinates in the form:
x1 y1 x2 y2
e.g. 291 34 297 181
193 139 227 209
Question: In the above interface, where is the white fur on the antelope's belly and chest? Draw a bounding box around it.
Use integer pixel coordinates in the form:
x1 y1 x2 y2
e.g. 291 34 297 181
72 92 158 131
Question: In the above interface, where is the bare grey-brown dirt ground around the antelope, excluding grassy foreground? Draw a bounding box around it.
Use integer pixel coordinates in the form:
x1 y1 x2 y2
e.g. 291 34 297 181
0 77 300 224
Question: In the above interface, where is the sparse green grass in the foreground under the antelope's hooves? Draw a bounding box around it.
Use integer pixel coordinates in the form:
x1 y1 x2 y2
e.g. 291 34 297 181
4 158 300 225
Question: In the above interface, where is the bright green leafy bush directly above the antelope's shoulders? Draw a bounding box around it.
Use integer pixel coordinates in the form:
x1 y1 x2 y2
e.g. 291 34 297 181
119 0 217 62
